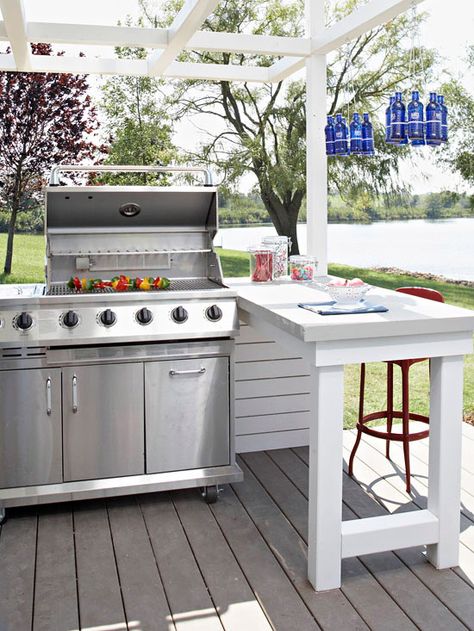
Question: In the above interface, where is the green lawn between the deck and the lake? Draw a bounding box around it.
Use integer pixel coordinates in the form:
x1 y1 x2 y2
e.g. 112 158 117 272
0 234 474 427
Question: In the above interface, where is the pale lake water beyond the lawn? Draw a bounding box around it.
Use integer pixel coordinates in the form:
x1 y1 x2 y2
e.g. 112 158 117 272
215 218 474 280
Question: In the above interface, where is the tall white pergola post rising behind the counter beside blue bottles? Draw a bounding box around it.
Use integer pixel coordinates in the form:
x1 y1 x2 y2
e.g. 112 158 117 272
306 0 328 274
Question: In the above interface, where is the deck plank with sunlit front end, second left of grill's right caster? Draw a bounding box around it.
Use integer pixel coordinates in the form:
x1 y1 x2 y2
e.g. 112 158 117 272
138 493 223 631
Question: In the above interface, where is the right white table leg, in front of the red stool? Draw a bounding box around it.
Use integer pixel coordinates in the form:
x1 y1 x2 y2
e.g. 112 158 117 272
428 355 464 569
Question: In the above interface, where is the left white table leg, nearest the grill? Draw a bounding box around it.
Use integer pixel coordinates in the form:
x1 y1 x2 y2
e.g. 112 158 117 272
308 366 344 591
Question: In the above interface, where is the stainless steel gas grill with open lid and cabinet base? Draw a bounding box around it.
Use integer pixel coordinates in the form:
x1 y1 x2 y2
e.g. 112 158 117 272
0 167 242 521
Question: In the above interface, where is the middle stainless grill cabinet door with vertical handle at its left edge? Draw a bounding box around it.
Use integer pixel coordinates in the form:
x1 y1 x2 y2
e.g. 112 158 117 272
63 363 145 481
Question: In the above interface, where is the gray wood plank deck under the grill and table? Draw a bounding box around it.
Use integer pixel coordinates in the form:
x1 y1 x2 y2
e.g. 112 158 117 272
0 425 474 631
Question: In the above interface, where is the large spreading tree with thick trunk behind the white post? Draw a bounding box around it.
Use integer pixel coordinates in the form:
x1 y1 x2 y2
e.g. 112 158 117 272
137 0 434 253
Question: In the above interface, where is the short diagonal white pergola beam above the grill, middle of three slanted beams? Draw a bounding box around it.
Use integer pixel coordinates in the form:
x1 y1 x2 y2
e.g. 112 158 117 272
148 0 219 76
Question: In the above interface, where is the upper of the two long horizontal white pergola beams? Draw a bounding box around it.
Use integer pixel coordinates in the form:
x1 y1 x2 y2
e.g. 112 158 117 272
20 22 311 57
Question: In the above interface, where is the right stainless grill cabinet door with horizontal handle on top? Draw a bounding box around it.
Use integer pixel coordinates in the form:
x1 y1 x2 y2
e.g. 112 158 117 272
145 357 229 473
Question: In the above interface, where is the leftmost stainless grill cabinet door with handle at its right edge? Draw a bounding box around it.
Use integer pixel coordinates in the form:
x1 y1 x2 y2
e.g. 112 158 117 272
0 369 62 488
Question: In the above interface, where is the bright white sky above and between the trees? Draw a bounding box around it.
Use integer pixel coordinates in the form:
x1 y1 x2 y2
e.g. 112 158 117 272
17 0 474 193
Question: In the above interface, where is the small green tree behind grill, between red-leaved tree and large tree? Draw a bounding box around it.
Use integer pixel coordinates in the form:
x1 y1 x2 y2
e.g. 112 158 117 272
98 20 177 184
